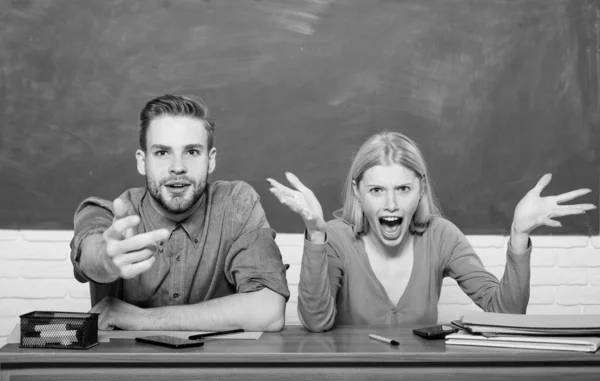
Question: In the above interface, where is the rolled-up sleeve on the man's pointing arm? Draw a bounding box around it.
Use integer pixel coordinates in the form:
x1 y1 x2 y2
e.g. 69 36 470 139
71 197 113 283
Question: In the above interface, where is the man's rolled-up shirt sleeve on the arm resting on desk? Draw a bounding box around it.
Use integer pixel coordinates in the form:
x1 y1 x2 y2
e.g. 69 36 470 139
225 184 290 301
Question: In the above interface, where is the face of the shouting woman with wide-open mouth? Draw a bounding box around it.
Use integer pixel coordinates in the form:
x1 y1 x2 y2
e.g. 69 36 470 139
354 164 422 247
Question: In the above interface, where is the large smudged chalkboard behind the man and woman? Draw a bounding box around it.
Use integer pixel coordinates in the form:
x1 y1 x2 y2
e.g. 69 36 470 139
0 0 600 235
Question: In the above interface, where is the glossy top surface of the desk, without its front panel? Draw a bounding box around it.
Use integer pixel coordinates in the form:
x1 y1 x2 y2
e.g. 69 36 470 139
0 326 600 366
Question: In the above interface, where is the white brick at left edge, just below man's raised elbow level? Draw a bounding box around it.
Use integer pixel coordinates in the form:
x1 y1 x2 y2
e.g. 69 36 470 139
0 278 67 298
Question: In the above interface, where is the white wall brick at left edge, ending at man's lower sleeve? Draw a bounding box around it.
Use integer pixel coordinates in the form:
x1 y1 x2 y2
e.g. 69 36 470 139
0 260 73 279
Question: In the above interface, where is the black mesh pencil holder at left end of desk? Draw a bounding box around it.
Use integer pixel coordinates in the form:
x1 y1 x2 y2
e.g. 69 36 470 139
20 311 98 349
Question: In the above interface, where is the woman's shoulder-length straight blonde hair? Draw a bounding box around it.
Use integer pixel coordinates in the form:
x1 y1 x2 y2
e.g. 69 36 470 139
334 131 441 236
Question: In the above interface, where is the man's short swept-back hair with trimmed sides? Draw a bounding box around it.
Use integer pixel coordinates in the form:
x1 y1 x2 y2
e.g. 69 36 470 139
139 94 215 152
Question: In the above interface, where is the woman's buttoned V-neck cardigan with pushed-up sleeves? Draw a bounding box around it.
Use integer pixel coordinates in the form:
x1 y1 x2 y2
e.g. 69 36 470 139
298 217 531 331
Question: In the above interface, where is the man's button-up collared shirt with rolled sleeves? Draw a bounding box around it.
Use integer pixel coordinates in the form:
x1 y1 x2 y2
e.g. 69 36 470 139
71 181 290 308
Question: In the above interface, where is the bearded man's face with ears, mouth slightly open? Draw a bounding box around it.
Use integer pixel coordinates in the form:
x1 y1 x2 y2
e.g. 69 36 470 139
136 115 216 214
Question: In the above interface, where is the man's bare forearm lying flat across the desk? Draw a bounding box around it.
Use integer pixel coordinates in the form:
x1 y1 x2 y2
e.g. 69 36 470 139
90 288 285 331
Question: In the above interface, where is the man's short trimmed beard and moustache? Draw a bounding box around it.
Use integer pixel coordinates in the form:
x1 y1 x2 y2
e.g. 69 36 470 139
146 176 207 214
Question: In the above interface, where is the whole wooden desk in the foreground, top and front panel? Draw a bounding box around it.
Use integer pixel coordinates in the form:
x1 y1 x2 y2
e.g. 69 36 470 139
0 326 600 381
